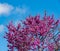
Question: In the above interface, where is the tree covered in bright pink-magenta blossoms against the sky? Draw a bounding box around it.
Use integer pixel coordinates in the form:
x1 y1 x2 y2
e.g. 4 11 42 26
4 14 60 51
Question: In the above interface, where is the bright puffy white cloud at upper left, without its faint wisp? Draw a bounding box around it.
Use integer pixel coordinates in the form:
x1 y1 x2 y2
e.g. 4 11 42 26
0 3 14 15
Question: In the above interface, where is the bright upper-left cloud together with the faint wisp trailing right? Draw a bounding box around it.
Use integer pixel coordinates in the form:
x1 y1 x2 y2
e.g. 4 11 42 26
0 3 28 15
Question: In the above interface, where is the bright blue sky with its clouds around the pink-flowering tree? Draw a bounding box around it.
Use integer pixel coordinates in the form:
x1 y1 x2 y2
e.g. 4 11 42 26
0 0 60 51
